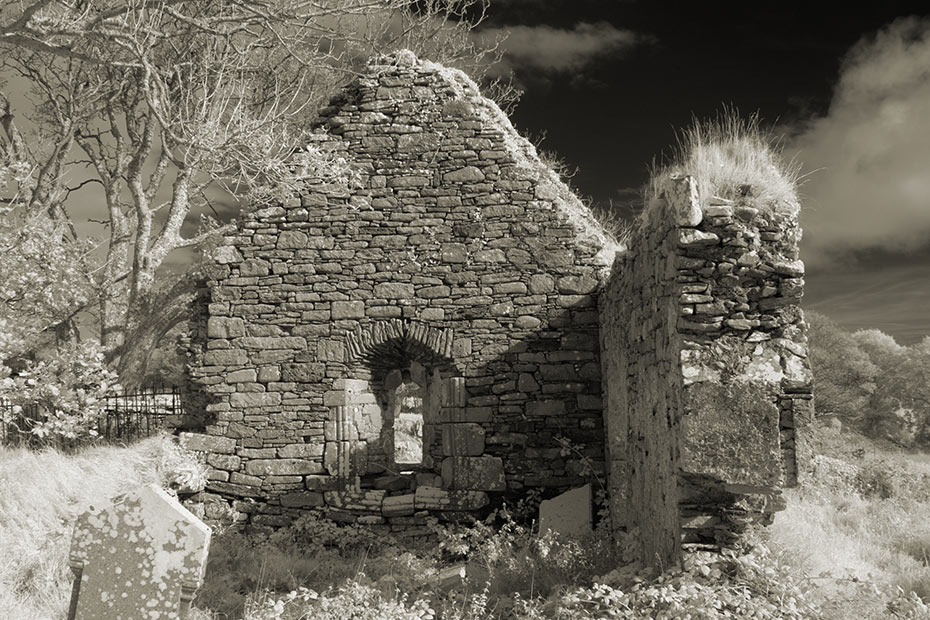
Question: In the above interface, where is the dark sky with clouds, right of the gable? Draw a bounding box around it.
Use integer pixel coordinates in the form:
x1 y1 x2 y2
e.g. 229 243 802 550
481 0 930 344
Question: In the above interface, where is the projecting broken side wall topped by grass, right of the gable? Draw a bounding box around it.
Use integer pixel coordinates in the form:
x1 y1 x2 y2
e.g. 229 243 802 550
600 177 812 565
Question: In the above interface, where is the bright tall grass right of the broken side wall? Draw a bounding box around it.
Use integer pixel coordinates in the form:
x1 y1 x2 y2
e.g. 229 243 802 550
770 426 930 620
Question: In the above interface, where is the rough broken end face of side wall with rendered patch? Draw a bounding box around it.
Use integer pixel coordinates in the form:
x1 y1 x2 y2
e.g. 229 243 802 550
668 180 813 546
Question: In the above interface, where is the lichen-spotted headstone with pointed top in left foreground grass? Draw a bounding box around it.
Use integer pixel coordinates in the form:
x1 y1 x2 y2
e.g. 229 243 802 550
68 485 211 620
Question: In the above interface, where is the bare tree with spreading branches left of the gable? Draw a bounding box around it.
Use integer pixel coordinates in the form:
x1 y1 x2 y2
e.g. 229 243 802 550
0 0 496 380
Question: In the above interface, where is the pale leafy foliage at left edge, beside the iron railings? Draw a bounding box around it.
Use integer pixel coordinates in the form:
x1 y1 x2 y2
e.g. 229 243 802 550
0 191 116 440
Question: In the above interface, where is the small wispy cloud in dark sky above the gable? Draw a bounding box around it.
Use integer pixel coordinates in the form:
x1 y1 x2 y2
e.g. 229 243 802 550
480 22 641 73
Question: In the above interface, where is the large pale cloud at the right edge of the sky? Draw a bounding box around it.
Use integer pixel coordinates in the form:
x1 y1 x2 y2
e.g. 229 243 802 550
793 18 930 266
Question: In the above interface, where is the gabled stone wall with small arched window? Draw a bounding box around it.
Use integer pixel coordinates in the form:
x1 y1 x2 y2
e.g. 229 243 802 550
185 53 617 529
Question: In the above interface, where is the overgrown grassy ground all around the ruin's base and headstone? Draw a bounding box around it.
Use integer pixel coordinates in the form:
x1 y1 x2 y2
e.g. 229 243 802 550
0 431 930 620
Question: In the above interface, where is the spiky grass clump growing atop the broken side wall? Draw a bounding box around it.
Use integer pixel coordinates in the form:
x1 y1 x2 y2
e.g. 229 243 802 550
647 107 801 212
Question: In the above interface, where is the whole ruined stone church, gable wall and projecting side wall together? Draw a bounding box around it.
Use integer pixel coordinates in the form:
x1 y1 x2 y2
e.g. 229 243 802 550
185 52 812 562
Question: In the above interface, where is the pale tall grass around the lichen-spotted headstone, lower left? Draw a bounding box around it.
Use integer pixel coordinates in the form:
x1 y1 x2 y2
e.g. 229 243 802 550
0 436 204 620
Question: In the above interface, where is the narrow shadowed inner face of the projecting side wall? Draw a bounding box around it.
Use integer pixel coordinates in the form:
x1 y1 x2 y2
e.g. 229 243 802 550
598 214 681 566
